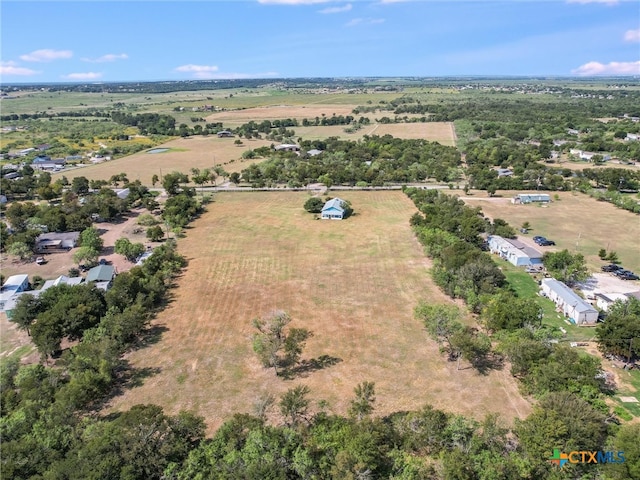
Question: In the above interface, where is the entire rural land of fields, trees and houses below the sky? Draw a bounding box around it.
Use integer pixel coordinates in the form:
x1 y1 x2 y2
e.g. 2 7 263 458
0 77 640 480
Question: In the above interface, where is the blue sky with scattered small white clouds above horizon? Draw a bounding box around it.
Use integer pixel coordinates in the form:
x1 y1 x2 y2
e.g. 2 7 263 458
0 0 640 83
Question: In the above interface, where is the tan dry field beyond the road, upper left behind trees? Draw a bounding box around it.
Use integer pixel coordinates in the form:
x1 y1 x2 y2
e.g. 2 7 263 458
53 135 273 186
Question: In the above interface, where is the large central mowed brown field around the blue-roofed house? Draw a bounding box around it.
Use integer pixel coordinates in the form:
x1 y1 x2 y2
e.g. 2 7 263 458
109 192 530 431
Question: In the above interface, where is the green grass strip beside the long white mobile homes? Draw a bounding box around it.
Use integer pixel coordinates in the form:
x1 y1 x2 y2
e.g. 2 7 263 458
494 256 595 342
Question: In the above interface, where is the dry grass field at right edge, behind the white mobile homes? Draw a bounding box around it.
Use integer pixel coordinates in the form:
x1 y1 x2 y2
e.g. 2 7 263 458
464 191 640 273
